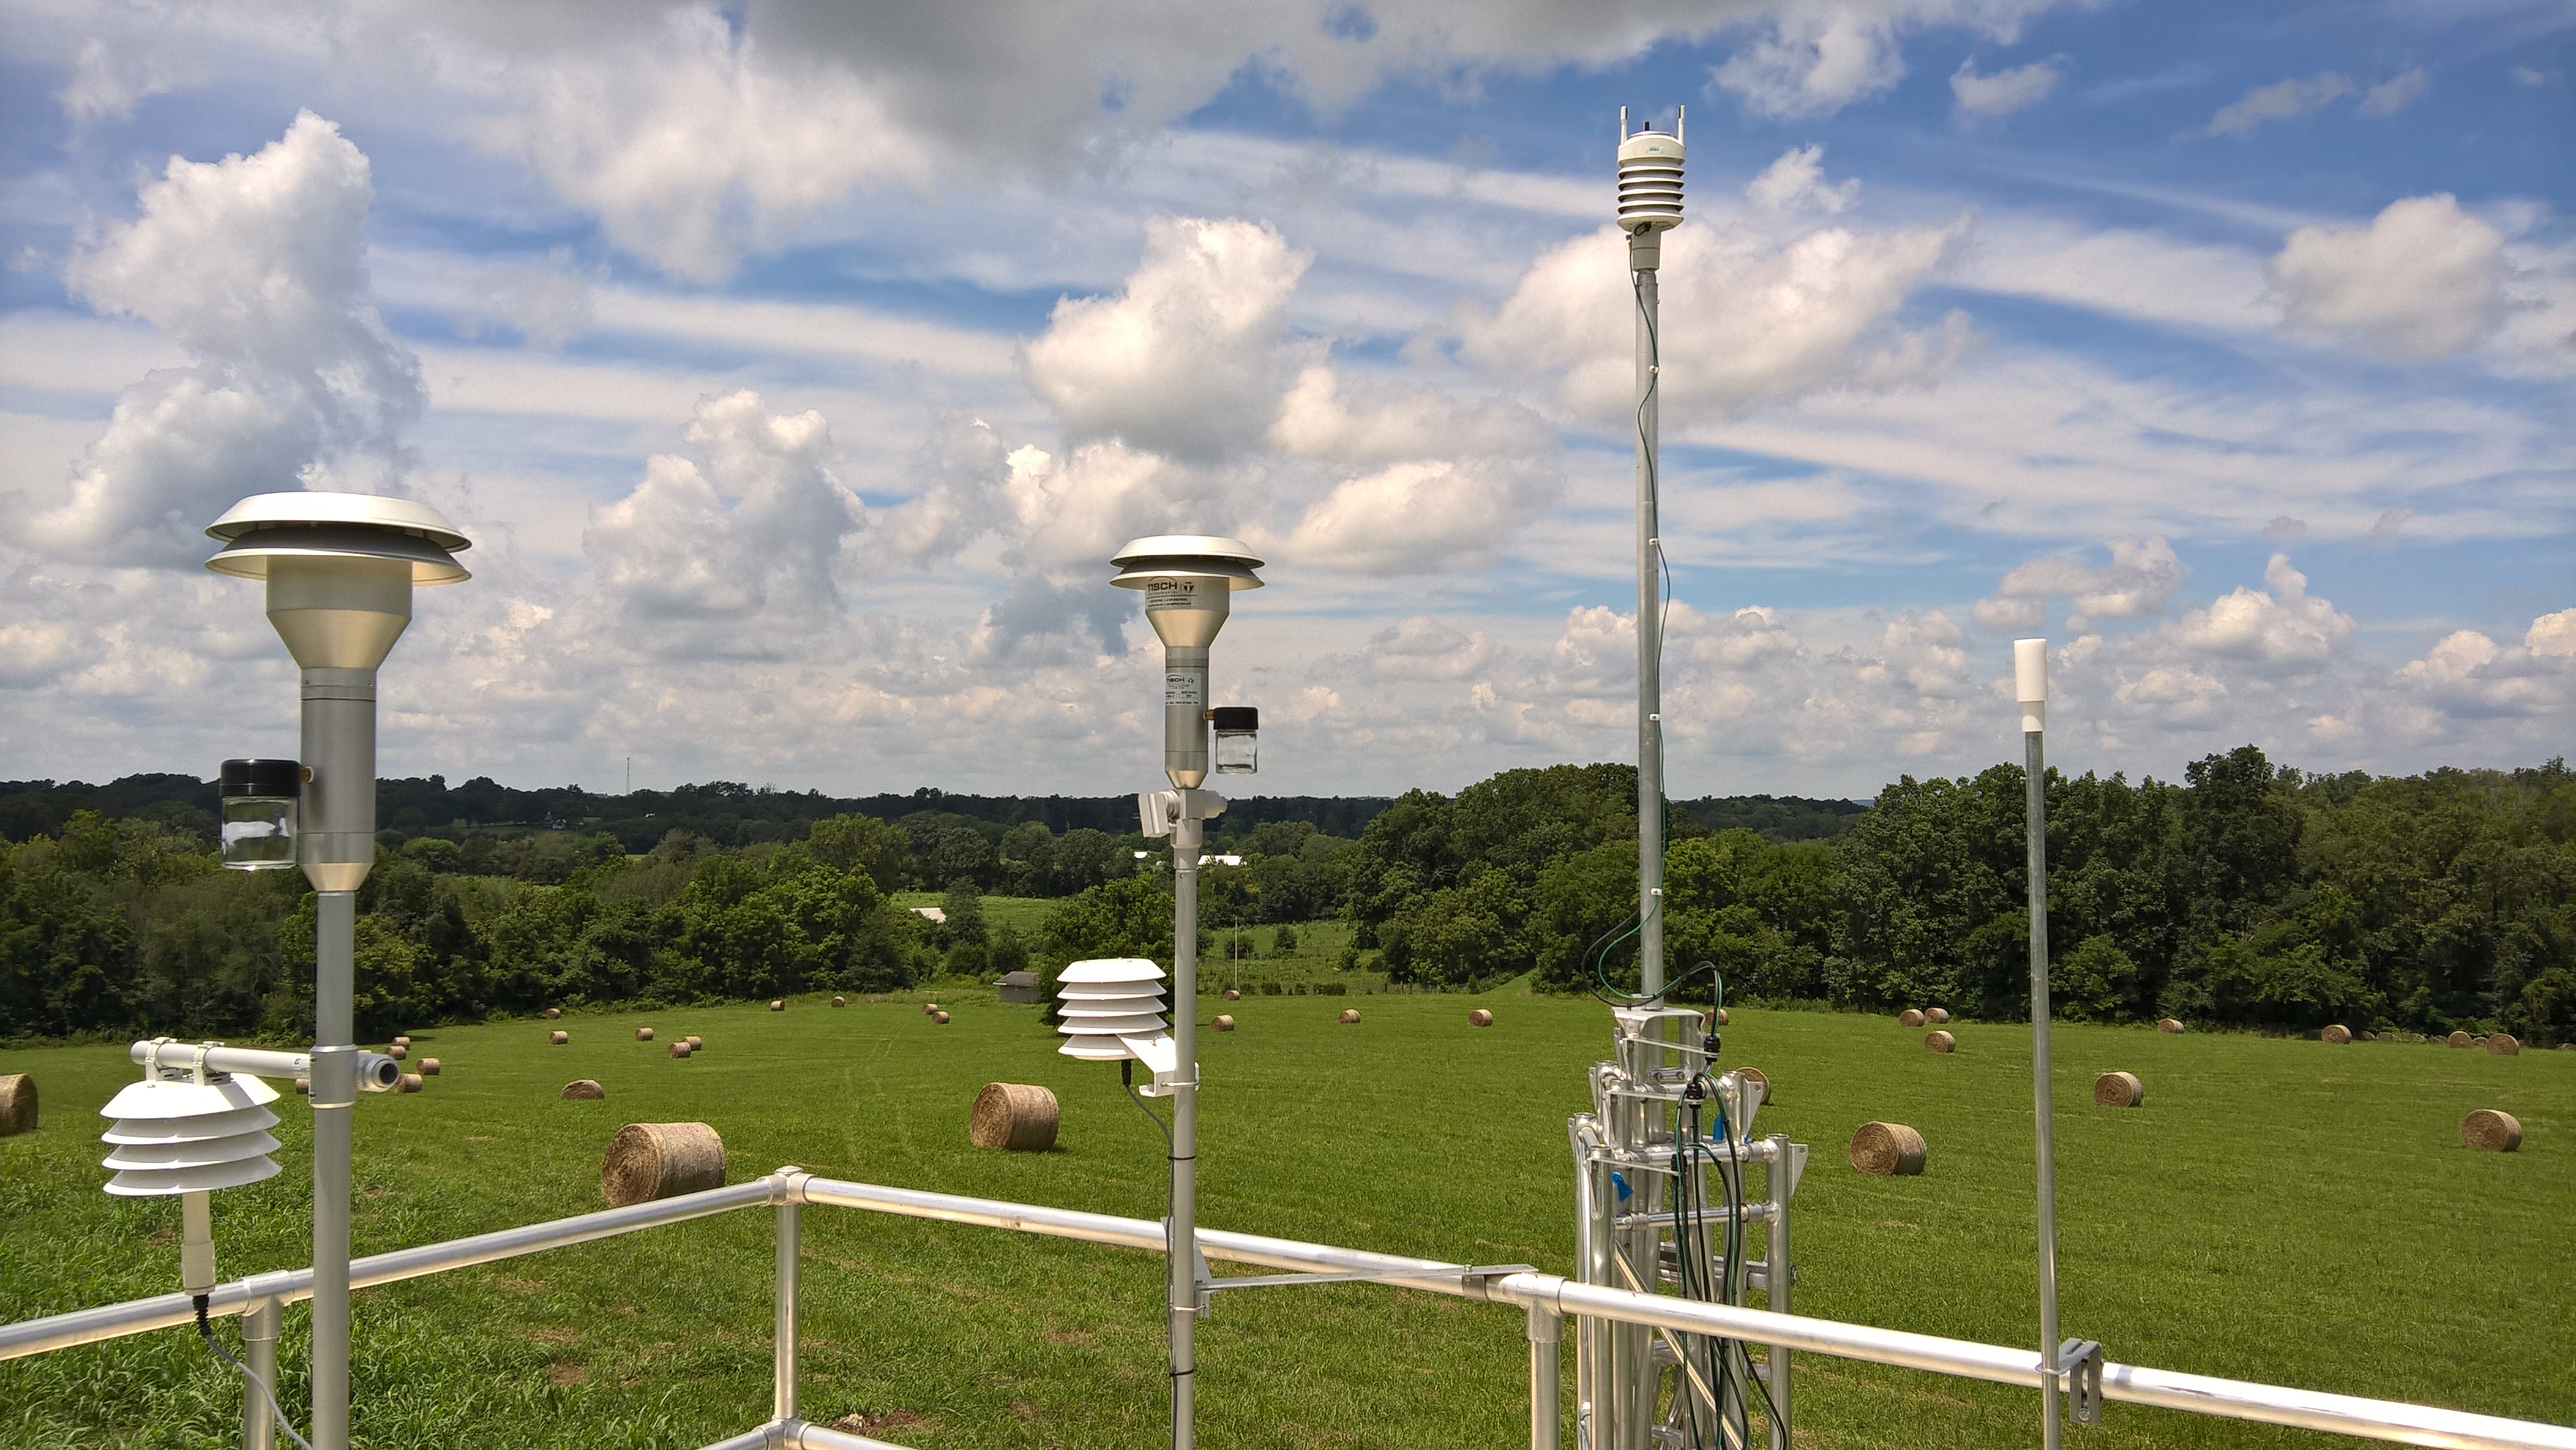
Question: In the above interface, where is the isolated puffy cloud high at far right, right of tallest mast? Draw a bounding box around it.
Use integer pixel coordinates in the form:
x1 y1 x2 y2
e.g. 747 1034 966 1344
2264 193 2512 363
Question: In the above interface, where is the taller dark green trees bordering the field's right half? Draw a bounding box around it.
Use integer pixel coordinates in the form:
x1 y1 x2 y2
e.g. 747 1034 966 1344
1345 745 2576 1043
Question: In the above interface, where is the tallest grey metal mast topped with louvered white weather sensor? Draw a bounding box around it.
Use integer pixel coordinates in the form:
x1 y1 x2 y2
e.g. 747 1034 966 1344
1618 105 1690 994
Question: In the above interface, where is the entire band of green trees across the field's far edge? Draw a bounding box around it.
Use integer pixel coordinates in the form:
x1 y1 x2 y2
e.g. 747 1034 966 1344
15 747 2576 1043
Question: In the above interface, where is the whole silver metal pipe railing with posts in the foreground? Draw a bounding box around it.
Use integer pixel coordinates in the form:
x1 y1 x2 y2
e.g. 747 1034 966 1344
0 1166 2576 1450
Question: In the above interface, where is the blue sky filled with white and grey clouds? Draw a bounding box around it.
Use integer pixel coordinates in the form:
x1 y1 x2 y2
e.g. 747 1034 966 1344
0 0 2576 798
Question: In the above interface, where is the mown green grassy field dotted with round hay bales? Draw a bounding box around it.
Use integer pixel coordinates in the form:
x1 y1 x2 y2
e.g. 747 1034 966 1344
0 986 2576 1450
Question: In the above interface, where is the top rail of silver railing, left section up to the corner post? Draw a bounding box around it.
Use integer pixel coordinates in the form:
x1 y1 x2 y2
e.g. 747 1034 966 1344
0 1177 773 1360
